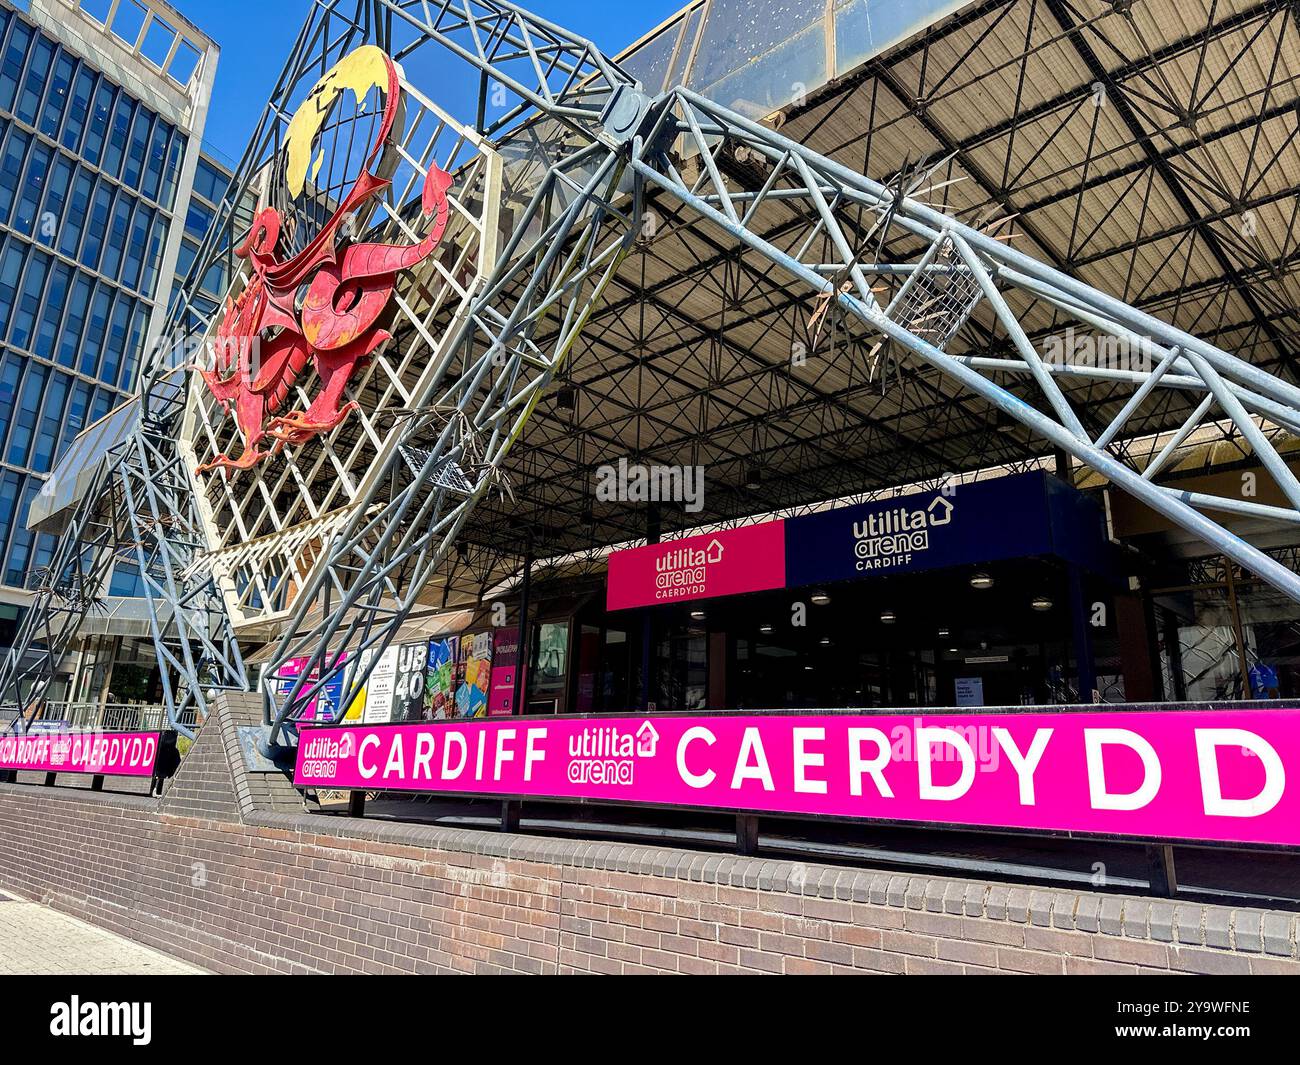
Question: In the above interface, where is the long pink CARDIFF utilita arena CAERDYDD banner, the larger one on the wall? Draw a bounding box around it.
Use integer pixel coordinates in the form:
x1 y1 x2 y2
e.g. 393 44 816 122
294 709 1300 845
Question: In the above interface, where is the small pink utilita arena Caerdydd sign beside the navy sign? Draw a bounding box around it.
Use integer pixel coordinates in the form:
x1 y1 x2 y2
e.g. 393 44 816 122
606 521 785 610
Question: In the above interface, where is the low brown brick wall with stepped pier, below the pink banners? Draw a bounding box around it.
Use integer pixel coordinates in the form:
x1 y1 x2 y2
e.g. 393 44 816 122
0 696 1300 974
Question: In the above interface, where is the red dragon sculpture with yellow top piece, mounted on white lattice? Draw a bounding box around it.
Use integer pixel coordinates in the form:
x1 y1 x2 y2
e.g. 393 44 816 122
196 46 451 473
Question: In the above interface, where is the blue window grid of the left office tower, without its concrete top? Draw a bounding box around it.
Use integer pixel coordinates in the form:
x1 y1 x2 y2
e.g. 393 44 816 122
0 8 186 588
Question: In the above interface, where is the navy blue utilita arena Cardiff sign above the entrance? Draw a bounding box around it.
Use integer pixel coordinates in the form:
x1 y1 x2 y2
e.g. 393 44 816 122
785 471 1109 586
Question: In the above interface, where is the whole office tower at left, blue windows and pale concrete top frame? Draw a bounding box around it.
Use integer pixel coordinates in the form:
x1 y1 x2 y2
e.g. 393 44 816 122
0 0 217 646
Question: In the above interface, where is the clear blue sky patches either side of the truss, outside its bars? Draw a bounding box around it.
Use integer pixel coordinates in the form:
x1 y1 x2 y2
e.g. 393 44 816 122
185 0 686 161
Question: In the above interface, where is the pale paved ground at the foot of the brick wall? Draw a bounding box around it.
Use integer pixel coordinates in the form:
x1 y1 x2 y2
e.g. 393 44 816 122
0 891 204 977
